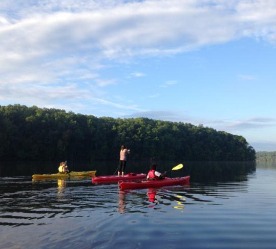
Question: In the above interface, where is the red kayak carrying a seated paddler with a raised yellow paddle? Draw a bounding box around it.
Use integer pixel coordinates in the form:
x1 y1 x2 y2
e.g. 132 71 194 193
119 176 190 190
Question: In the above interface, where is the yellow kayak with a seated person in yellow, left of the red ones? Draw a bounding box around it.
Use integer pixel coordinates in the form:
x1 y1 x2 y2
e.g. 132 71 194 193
32 170 96 180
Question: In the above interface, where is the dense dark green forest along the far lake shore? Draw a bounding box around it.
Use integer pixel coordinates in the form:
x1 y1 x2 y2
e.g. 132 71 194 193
0 104 256 162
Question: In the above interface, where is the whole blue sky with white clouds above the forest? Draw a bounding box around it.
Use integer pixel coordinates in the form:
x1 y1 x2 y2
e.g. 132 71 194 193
0 0 276 151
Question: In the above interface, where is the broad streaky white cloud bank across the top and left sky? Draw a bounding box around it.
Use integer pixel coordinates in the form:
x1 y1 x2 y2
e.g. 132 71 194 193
0 0 276 117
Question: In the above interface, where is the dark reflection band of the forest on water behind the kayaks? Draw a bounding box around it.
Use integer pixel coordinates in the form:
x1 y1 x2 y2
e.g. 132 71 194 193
0 161 256 181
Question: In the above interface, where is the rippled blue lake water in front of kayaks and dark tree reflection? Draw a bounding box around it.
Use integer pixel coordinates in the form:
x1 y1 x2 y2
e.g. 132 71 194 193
0 162 276 249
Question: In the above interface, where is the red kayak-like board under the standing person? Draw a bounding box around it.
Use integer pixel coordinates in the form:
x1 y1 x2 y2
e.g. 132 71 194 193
92 173 147 184
